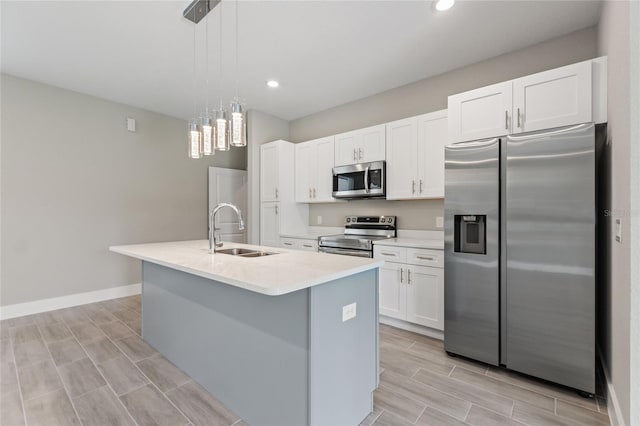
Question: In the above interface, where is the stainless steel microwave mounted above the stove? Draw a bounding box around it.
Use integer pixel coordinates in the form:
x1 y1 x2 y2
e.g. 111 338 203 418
333 161 386 199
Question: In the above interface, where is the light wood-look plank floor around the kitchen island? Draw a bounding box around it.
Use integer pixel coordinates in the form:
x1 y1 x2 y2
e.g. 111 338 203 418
0 296 609 426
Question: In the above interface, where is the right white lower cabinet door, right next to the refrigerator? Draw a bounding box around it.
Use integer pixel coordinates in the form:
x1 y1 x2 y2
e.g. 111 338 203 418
406 265 444 330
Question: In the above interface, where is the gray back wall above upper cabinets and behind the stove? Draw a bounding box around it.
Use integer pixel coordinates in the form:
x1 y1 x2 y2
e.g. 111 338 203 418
290 27 597 229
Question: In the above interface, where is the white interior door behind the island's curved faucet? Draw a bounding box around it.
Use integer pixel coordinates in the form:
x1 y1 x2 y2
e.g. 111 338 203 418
209 167 248 243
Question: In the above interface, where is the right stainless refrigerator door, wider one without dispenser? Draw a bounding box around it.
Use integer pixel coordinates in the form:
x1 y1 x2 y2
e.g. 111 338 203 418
503 124 596 393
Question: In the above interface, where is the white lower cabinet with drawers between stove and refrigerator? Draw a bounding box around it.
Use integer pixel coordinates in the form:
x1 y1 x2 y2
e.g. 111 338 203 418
373 245 444 330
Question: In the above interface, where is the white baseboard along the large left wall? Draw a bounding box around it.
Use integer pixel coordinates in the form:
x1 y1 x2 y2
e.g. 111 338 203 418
0 283 142 320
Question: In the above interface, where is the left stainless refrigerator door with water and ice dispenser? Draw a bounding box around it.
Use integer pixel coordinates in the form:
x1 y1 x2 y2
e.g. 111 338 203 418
444 139 500 365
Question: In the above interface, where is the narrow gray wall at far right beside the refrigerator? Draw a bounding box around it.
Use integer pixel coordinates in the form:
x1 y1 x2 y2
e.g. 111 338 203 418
598 1 637 425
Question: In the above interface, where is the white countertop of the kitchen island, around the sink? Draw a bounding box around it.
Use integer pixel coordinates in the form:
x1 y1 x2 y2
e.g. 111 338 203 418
109 240 384 296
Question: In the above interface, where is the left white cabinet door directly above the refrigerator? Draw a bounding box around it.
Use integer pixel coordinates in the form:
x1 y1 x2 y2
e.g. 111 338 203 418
448 81 512 142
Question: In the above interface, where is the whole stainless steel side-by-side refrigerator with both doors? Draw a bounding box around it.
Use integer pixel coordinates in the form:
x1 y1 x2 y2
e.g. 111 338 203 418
445 123 603 394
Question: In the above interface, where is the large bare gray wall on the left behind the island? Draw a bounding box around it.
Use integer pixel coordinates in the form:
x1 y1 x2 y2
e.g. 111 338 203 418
0 74 246 306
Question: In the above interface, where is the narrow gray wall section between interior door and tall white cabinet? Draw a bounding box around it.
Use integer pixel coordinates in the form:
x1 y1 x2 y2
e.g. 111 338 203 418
247 110 293 244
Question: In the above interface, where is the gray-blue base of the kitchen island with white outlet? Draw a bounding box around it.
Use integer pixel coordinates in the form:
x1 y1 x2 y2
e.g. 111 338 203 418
142 261 378 426
